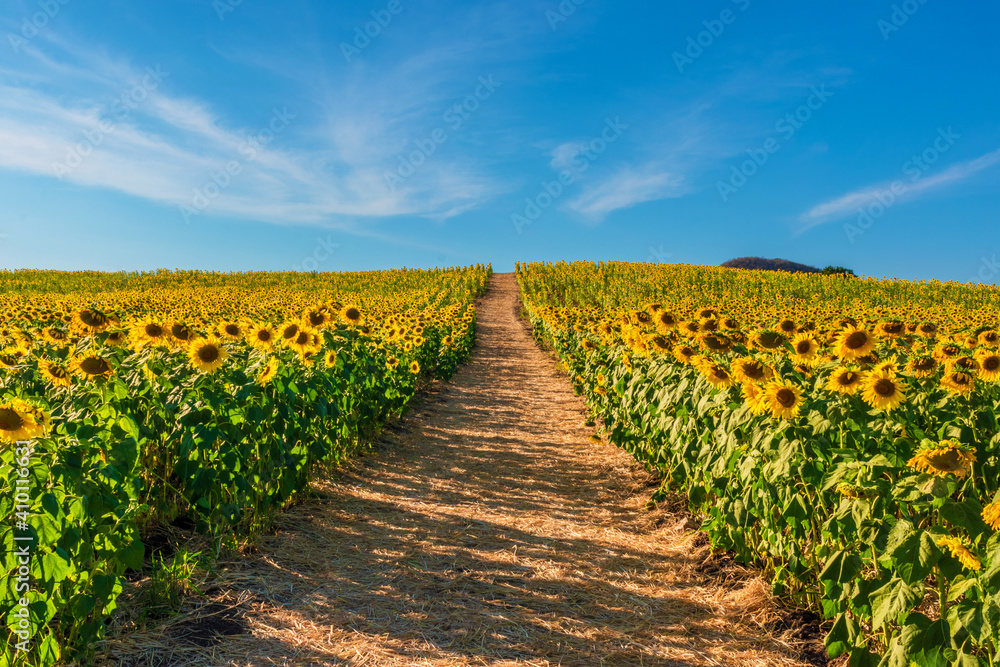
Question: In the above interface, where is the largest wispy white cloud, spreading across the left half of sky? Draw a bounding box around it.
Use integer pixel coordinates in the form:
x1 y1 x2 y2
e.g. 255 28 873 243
0 36 498 228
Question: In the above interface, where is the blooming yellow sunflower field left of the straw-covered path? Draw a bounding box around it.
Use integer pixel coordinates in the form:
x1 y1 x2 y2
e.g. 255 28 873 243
0 265 491 665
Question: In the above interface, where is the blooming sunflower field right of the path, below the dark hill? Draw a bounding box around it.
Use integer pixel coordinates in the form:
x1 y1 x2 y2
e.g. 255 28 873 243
517 263 1000 667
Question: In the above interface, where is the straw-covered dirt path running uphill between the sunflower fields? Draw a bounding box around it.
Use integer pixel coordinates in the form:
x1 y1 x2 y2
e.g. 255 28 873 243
109 274 816 667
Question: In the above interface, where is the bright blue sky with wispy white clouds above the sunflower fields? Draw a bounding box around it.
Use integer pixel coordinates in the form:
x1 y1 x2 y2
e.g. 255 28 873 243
0 0 1000 283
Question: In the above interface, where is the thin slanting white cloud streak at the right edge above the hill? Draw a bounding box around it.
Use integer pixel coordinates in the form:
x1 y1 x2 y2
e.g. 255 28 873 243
799 149 1000 231
